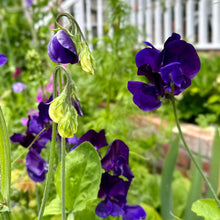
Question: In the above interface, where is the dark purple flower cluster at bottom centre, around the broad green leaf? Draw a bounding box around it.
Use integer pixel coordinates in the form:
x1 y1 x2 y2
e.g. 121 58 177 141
71 130 146 220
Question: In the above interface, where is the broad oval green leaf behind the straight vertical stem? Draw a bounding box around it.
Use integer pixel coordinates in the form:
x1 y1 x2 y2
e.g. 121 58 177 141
55 142 102 212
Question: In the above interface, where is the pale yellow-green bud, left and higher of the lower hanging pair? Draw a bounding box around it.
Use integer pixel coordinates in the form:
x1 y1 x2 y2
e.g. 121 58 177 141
49 89 67 123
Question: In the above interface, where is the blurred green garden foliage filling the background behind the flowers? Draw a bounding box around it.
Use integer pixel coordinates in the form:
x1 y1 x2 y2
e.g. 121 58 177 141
0 0 220 220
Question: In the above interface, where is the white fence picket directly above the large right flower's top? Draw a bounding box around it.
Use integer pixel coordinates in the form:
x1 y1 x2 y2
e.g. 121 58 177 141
174 0 183 36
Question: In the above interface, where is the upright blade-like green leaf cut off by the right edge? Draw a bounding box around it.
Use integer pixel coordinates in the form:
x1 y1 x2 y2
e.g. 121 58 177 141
206 129 220 198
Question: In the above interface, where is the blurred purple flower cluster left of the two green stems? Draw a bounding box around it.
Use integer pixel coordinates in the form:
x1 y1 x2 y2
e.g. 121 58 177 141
10 99 52 182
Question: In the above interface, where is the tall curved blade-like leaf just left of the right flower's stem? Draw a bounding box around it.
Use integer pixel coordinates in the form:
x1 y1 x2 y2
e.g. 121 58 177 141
160 136 179 220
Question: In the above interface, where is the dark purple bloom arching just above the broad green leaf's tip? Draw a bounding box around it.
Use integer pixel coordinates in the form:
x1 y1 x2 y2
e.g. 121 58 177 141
71 129 108 150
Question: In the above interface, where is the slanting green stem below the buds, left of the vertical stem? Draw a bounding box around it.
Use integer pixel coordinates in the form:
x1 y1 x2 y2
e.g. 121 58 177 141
38 122 57 220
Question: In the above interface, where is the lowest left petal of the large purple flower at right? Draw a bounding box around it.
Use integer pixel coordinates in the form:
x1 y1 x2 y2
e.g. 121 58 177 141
128 81 161 111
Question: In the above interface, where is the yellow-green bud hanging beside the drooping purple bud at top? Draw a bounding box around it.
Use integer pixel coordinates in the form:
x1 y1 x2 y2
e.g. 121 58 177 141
79 46 94 75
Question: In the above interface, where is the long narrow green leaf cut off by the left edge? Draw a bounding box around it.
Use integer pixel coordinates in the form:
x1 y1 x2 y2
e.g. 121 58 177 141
0 107 11 207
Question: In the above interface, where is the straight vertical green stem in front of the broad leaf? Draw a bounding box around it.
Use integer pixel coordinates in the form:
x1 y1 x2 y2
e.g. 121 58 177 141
61 138 66 220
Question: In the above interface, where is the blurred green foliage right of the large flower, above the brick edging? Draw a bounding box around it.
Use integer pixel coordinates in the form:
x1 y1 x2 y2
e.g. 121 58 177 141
178 54 220 127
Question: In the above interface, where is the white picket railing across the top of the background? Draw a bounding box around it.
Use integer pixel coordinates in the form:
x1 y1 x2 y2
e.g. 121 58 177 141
57 0 220 50
